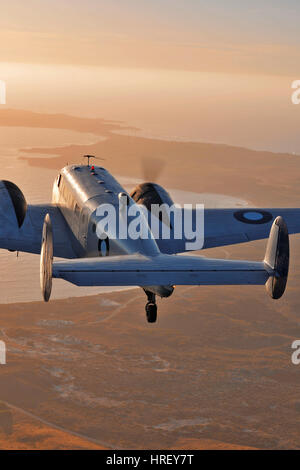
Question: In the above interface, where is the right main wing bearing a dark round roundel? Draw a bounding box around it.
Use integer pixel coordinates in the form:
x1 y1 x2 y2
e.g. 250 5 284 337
156 207 300 254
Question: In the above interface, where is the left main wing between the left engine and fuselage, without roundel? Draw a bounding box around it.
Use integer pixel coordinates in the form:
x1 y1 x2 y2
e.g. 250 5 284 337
0 204 76 258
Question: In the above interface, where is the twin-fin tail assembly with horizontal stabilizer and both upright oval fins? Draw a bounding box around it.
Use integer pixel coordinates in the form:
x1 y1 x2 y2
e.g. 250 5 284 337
40 214 289 302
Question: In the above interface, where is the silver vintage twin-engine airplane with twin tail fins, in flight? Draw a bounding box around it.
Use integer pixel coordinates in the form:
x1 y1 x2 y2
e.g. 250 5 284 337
0 157 300 323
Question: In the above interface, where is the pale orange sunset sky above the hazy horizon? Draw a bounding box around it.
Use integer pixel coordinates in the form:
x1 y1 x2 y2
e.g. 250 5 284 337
0 0 300 75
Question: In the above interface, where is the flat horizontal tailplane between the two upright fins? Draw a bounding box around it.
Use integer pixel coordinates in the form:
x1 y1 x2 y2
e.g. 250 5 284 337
52 254 273 287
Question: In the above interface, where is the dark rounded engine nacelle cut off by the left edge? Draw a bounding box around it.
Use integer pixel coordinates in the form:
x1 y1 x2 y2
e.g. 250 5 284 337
0 180 27 228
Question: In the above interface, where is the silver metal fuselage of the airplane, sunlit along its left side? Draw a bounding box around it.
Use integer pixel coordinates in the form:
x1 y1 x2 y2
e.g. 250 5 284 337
52 165 173 296
